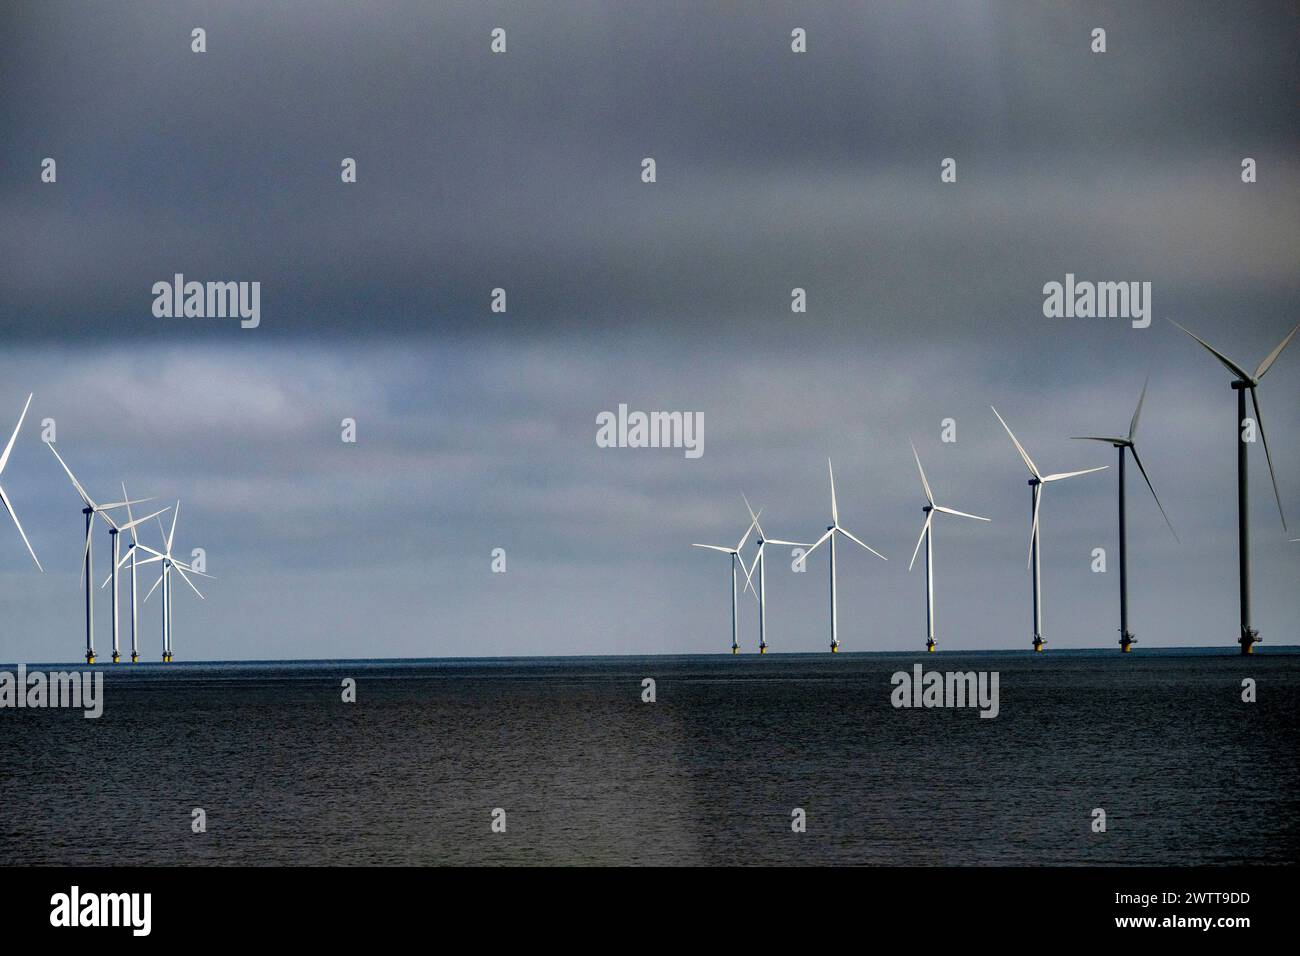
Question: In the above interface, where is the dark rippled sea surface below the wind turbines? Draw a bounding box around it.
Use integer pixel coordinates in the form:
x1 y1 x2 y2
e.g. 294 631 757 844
0 648 1300 866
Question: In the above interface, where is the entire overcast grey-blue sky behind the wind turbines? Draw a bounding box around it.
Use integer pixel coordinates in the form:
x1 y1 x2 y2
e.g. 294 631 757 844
0 0 1300 661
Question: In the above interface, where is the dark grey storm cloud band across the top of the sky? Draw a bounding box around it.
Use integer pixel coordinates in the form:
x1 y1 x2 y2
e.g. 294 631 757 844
0 3 1300 341
